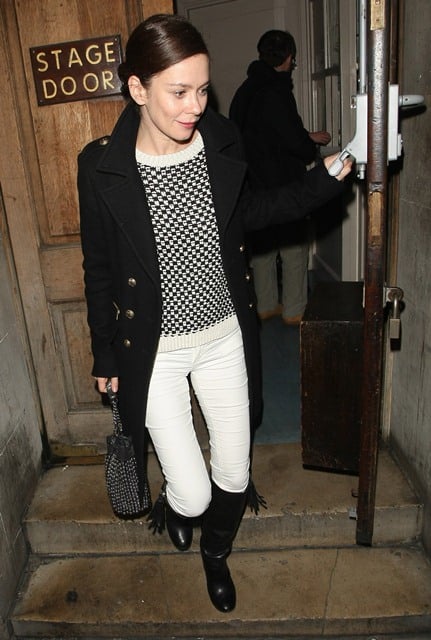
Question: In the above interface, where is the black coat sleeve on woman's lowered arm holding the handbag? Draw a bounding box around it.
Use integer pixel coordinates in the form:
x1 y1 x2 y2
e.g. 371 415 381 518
78 145 118 378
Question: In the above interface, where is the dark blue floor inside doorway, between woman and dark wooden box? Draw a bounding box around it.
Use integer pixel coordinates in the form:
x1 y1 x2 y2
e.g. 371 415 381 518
255 317 301 444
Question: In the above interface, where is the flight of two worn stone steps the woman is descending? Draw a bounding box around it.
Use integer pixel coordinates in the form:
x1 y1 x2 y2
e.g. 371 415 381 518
11 444 431 640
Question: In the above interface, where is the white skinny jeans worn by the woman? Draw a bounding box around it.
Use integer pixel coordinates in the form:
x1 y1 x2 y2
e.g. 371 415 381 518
146 328 250 517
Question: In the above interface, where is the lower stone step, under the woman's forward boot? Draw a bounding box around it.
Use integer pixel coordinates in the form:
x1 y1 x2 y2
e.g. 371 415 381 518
11 545 431 640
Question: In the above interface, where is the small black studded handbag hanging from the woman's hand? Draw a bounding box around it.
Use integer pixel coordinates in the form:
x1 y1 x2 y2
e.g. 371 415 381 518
105 381 152 519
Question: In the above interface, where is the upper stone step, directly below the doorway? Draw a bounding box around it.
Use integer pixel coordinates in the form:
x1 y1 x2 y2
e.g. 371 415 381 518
24 443 423 555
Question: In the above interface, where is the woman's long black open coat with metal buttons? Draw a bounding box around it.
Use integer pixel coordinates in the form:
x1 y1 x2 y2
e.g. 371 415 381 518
78 103 341 480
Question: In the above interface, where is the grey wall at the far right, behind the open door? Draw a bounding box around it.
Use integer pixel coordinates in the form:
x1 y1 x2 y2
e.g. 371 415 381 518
391 0 431 551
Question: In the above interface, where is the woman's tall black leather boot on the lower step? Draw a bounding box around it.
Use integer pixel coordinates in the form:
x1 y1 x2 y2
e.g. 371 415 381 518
200 483 246 613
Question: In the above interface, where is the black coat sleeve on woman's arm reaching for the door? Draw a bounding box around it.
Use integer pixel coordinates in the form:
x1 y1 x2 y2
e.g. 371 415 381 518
239 163 345 231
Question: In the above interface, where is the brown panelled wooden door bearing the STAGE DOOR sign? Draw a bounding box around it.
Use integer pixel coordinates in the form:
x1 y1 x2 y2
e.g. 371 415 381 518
0 0 173 456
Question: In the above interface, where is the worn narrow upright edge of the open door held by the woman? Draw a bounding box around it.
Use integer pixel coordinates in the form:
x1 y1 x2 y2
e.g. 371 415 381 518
356 0 398 545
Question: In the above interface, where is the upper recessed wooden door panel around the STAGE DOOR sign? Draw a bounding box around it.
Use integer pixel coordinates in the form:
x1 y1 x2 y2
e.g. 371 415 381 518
17 0 129 245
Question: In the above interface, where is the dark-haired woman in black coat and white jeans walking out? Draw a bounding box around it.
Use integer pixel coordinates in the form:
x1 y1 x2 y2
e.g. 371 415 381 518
78 15 350 612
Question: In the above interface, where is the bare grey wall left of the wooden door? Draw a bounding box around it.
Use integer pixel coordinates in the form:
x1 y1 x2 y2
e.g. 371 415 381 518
0 214 42 638
